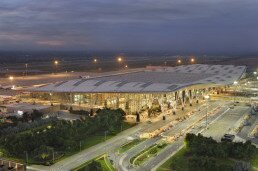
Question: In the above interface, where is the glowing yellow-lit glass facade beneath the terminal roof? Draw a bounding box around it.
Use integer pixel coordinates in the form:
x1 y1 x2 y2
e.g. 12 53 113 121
29 88 208 115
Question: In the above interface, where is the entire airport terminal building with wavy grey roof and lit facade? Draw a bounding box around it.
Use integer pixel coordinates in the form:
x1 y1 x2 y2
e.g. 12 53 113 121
31 64 246 114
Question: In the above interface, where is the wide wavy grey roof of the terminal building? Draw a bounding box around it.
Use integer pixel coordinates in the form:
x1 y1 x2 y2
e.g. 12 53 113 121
32 64 246 93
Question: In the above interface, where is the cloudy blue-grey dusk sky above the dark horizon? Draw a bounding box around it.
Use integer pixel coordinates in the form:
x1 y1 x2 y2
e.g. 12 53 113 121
0 0 258 53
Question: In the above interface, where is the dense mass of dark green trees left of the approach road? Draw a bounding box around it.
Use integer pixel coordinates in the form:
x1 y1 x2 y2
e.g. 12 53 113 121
0 109 128 164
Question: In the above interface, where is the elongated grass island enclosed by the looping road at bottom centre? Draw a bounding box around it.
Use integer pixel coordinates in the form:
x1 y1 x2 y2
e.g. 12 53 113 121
130 143 167 165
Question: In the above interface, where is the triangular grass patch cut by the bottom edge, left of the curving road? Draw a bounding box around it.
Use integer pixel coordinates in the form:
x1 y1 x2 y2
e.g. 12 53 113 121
72 154 115 171
